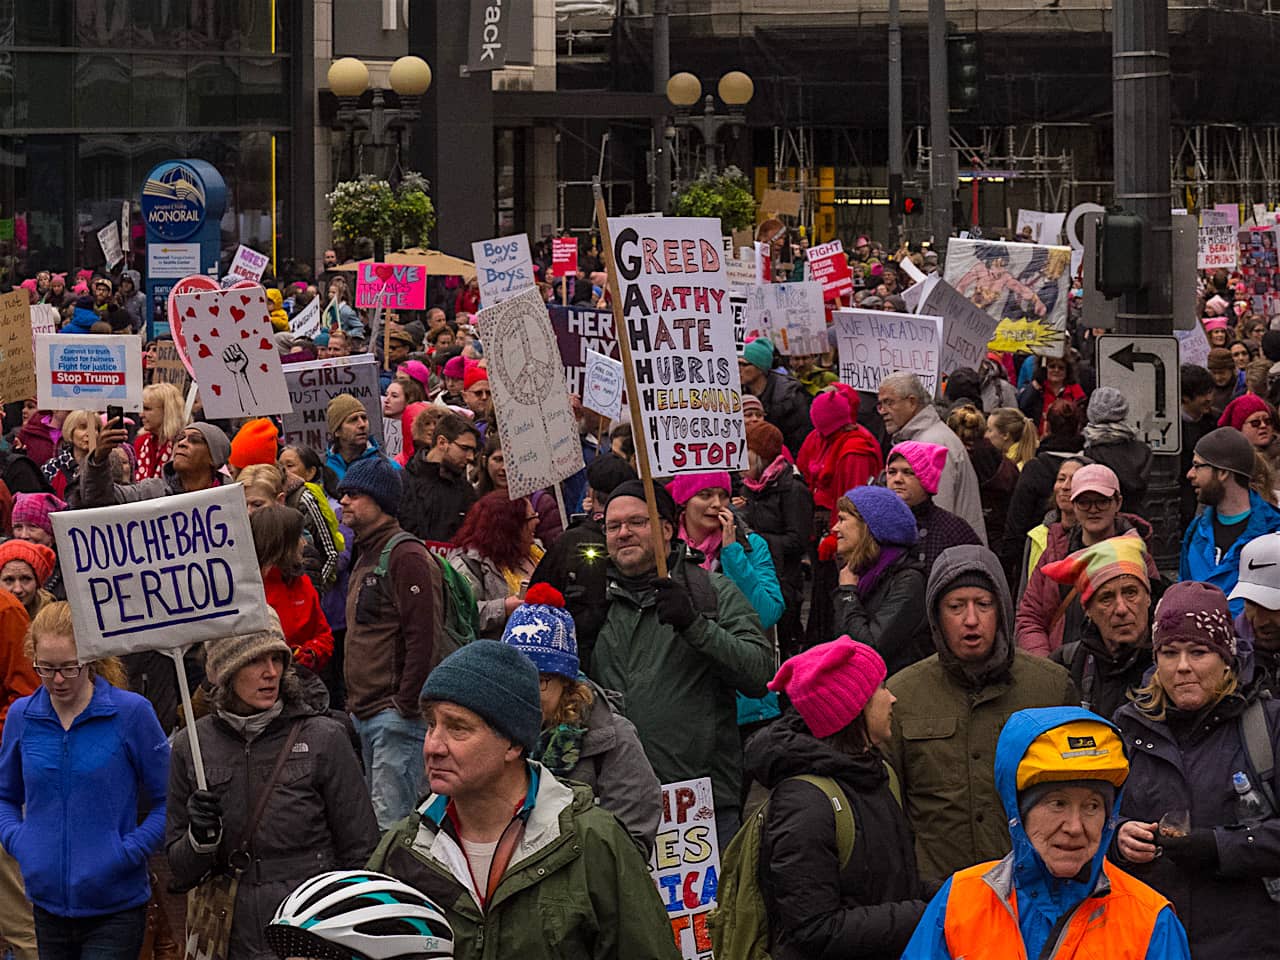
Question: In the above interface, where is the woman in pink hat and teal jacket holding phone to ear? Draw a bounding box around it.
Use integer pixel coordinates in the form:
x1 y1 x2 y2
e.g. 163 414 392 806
667 471 786 732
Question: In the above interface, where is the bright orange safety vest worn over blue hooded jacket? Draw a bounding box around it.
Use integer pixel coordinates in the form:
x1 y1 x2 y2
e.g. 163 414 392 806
943 860 1169 960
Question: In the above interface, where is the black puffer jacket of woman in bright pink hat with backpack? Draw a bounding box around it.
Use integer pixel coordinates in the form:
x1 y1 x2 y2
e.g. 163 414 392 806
746 710 925 960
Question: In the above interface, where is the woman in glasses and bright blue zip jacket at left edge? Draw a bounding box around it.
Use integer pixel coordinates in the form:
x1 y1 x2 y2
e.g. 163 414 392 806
0 603 169 960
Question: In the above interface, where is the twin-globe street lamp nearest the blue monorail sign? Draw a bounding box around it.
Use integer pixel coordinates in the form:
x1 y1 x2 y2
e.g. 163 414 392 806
328 56 431 187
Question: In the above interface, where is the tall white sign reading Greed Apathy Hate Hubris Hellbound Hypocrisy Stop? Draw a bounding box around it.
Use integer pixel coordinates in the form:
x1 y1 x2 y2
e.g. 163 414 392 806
609 216 746 476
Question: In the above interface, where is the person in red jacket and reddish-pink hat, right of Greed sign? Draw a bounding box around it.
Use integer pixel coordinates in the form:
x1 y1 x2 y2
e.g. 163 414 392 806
796 384 884 646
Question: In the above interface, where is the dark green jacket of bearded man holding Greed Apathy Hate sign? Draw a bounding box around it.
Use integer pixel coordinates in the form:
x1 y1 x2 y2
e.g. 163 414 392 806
585 541 773 813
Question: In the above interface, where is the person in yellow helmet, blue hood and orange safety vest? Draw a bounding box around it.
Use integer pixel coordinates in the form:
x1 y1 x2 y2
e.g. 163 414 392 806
902 707 1187 960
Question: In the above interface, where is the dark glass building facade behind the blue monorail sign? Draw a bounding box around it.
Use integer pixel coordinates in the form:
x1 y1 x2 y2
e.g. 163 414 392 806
0 0 312 283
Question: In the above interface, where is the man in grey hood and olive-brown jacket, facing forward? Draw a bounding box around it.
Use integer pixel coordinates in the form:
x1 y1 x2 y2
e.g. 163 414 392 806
888 545 1080 883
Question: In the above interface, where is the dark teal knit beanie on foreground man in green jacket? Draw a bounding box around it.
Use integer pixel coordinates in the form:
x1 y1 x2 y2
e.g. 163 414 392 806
420 640 543 753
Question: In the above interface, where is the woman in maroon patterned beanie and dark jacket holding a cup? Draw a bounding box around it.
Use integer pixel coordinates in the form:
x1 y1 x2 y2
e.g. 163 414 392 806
1111 581 1280 960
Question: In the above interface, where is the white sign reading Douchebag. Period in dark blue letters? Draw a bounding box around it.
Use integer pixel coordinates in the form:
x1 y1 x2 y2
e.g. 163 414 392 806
52 484 268 663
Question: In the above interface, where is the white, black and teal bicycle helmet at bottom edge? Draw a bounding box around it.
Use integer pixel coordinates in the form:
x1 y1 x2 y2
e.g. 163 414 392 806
266 870 453 960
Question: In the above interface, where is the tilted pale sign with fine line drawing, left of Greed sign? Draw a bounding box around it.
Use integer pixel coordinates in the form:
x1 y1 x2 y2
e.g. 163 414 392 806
476 287 582 498
